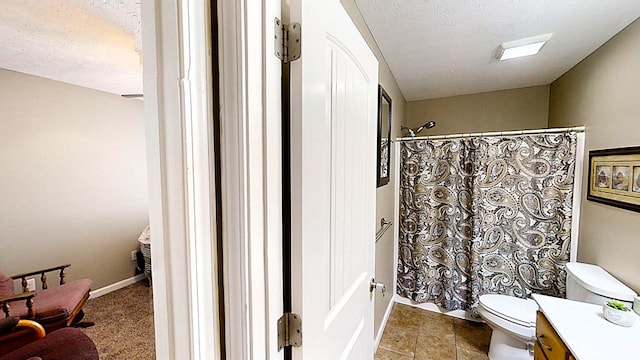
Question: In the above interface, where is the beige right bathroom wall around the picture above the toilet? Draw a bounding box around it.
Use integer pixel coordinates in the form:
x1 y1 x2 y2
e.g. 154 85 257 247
549 20 640 292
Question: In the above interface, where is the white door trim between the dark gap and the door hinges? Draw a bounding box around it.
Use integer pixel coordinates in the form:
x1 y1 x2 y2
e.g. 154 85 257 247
218 0 282 359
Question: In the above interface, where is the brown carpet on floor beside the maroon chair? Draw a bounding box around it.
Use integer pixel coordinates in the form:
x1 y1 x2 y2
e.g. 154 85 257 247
82 280 155 360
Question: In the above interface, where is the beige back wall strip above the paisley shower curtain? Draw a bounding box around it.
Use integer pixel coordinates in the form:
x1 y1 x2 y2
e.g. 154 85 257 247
403 85 549 136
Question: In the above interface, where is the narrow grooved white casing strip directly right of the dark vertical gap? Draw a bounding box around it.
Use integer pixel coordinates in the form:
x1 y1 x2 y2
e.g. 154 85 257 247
218 1 251 359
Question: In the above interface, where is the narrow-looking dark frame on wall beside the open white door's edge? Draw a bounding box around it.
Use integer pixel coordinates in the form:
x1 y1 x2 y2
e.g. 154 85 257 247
376 85 391 187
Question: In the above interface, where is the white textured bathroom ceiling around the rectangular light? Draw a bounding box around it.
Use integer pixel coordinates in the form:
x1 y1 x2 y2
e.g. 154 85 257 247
356 0 640 101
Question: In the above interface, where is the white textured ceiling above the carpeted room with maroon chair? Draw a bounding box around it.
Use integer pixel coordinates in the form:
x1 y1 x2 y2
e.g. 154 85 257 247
0 0 142 94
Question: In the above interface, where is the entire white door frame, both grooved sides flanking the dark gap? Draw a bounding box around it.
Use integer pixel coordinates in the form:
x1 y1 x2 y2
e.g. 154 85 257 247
142 0 282 359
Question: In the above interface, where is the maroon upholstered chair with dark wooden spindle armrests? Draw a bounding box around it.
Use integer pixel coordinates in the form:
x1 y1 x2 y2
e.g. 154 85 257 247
0 264 91 355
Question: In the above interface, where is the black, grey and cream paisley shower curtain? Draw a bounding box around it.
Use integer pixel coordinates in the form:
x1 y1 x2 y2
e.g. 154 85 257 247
397 132 577 315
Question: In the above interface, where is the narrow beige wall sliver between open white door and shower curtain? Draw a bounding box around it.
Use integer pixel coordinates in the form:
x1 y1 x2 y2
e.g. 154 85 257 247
342 0 406 336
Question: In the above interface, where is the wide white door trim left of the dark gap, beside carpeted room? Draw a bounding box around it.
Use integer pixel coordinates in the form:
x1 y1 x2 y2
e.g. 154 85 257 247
142 0 220 359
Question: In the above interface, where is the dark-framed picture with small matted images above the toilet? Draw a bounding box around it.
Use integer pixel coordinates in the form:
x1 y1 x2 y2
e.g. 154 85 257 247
587 146 640 212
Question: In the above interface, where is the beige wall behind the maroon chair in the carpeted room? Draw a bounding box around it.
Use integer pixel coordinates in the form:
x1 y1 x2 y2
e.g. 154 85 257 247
0 69 148 289
